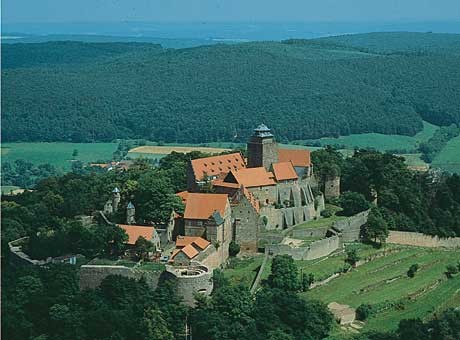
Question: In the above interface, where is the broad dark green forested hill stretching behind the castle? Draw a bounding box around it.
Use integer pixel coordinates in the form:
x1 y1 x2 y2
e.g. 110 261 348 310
2 33 460 143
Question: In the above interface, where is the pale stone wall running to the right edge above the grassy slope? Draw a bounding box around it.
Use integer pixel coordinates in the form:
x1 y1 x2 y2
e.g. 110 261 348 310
386 230 460 248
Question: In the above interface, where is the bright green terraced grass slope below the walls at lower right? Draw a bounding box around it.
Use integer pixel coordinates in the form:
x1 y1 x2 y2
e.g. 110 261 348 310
298 246 460 330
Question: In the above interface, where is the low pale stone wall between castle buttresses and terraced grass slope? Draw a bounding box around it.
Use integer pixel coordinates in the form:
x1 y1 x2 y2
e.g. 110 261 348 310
267 236 340 260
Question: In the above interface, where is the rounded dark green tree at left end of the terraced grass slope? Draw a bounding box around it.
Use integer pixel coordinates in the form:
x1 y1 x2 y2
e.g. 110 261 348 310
267 255 300 291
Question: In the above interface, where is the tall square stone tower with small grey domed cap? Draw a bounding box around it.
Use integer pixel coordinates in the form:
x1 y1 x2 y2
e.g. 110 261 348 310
248 124 278 171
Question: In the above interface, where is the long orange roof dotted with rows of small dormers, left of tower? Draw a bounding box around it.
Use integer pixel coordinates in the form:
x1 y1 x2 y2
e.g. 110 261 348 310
191 152 246 181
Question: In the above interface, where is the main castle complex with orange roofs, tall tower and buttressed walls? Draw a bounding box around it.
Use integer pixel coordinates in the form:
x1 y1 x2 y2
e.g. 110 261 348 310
178 124 324 264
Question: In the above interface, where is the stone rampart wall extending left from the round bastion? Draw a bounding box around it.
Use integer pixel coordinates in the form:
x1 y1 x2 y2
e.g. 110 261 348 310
79 265 162 289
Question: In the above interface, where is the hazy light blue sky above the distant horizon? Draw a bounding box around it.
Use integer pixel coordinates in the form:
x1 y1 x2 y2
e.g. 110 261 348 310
2 0 460 23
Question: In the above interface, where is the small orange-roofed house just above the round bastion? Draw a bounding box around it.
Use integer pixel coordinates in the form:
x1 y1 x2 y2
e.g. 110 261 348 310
170 236 211 266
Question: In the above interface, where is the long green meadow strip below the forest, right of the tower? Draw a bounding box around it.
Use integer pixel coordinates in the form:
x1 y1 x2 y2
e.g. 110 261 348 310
302 122 438 151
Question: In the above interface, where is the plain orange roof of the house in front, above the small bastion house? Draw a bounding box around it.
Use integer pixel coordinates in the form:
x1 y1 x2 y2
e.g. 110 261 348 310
184 193 228 220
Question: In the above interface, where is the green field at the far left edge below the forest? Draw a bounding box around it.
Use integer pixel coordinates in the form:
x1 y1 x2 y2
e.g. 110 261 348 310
1 143 118 171
